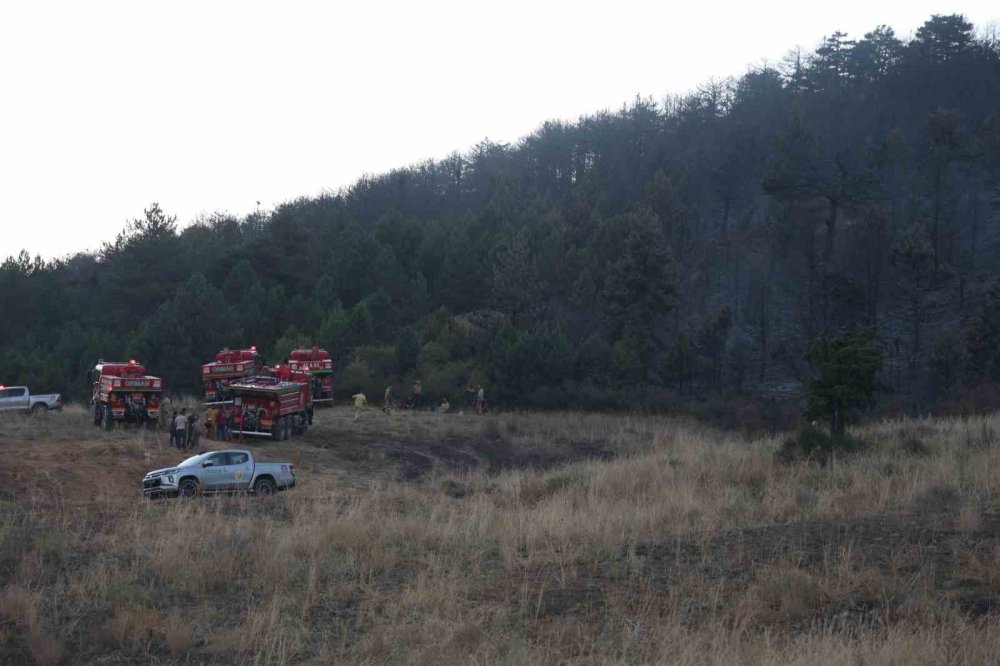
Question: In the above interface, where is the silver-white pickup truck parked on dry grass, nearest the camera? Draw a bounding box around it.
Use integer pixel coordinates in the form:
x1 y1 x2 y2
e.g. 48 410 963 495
142 450 295 497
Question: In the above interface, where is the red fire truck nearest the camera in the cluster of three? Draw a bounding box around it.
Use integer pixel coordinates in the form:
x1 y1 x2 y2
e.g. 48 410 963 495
229 374 313 441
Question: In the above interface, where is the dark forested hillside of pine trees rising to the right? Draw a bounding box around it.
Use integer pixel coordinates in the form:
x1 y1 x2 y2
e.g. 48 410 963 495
0 16 1000 420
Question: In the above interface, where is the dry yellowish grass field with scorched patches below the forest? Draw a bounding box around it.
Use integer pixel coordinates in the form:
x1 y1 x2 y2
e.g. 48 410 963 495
0 408 1000 665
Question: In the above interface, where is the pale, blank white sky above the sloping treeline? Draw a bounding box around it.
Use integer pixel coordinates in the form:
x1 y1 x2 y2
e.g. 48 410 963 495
0 0 1000 259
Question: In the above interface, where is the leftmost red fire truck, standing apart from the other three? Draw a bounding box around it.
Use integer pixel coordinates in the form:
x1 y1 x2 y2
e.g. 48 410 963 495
87 359 163 430
